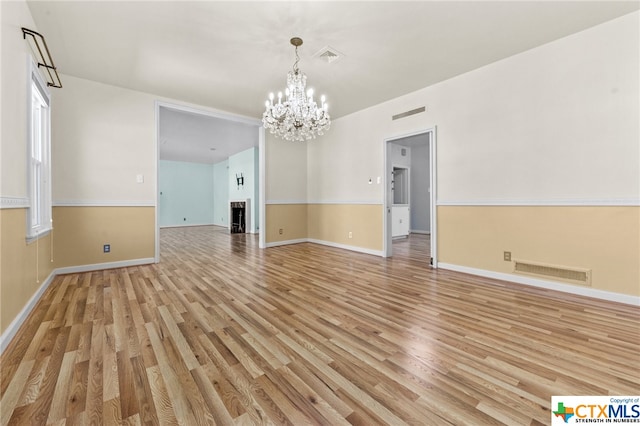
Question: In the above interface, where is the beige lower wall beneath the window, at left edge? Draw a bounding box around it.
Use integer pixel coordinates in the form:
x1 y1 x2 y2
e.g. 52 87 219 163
0 209 53 334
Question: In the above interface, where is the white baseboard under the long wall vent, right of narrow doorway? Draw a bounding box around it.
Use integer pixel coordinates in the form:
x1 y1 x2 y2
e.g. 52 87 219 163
438 262 640 306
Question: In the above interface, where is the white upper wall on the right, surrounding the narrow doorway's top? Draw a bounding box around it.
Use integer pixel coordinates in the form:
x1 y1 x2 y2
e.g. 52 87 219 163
307 12 640 203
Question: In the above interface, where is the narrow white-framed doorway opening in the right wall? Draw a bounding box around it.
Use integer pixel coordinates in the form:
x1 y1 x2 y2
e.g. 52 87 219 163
383 127 438 267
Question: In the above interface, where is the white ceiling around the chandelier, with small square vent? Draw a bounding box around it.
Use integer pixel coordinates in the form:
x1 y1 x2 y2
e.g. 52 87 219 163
28 0 639 163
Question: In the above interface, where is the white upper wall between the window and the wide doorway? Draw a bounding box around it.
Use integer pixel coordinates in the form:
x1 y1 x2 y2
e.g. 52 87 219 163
52 75 157 205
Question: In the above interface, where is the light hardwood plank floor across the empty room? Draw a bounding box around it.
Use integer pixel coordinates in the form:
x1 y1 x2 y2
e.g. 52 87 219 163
0 227 640 425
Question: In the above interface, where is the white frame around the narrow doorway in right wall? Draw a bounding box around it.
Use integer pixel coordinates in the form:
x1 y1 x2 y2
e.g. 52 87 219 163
382 126 438 268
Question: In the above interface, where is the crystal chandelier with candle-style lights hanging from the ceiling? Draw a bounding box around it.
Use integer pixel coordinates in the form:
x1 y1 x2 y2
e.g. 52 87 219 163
262 37 331 141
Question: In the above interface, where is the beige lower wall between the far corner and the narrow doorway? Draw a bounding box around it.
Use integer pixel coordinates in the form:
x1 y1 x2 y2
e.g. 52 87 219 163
307 204 383 251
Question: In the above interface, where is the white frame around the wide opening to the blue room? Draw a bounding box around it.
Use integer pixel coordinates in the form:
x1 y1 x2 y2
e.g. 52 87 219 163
155 101 265 263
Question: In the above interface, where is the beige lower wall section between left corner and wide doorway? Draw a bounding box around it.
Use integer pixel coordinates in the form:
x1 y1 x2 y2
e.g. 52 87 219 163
53 207 155 268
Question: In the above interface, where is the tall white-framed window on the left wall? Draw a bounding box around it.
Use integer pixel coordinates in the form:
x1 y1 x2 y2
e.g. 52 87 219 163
27 61 51 239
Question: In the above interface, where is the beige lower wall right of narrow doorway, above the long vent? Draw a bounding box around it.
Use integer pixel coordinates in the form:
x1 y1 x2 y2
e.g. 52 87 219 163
438 206 640 296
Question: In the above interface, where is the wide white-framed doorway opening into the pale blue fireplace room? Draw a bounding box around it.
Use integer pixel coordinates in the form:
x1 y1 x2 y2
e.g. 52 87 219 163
155 101 265 263
